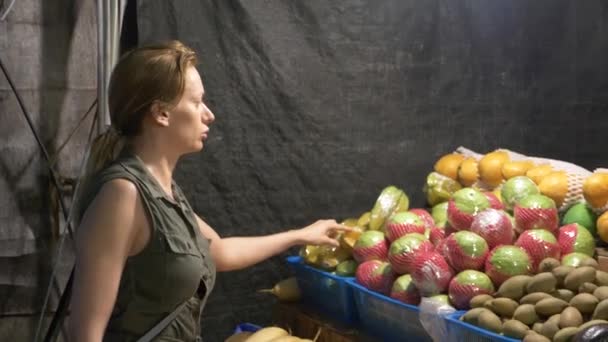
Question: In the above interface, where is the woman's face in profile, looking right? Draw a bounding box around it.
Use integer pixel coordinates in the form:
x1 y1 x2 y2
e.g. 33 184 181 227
169 66 215 153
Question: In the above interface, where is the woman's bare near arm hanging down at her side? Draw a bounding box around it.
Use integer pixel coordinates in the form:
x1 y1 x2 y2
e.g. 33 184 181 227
69 179 149 342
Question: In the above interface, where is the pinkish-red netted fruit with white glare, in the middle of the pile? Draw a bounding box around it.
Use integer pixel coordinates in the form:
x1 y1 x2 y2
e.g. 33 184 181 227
471 209 515 249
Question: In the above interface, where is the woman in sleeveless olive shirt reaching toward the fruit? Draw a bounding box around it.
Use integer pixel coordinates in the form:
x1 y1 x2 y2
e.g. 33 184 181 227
70 41 347 342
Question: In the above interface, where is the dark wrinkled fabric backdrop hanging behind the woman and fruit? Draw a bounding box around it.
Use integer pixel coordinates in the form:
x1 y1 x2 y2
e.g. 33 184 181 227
137 0 608 341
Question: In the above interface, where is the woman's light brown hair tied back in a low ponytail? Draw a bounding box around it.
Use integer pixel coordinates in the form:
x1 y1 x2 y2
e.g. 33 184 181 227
76 41 197 220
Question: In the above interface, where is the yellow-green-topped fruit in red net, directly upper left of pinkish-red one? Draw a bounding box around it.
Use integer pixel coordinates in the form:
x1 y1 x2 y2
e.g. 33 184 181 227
388 233 435 274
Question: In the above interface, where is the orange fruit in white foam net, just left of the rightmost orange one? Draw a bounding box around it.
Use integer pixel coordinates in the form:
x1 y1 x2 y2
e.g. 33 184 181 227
538 171 584 211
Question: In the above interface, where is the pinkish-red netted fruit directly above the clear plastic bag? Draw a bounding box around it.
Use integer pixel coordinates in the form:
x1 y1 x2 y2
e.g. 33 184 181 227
411 252 454 296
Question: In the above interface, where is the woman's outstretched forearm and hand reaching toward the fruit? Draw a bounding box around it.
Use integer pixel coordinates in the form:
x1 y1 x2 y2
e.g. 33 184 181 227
196 216 349 271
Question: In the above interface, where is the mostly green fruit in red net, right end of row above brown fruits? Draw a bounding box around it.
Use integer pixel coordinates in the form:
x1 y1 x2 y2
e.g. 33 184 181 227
485 245 532 286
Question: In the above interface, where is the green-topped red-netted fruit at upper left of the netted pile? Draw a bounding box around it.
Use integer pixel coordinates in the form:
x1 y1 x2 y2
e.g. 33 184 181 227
448 188 490 230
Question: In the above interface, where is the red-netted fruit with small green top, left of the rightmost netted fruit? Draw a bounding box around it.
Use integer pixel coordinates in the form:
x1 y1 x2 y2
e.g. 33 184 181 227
515 229 561 272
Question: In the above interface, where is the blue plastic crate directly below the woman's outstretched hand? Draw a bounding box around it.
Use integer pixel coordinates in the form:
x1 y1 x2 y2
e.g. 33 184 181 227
287 256 357 327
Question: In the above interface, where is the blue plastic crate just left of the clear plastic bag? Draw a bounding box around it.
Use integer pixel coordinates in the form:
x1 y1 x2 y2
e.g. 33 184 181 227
348 278 432 342
